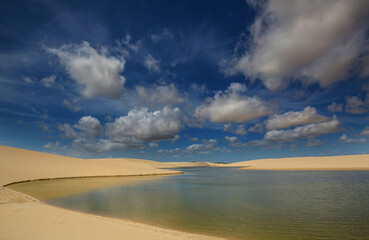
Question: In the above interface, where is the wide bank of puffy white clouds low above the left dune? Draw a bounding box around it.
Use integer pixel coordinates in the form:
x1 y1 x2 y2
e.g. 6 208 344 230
58 106 183 153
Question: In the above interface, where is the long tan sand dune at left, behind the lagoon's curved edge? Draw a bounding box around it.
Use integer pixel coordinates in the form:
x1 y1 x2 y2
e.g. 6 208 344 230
0 146 183 185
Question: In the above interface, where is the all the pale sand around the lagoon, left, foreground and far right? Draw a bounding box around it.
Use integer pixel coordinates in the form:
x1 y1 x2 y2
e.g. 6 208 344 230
0 145 369 240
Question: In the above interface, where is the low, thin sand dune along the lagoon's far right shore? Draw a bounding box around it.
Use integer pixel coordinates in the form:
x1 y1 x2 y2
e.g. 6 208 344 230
224 154 369 170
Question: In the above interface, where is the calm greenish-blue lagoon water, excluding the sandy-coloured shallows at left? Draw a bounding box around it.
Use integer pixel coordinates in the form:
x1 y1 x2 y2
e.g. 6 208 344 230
47 168 369 240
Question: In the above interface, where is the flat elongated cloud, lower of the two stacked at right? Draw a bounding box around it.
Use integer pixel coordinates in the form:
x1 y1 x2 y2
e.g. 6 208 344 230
264 117 340 142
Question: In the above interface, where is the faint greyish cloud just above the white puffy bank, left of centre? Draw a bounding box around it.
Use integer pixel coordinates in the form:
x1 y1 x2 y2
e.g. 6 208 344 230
136 83 186 107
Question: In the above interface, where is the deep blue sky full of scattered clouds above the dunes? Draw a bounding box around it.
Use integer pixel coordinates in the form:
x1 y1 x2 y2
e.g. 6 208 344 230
0 0 369 162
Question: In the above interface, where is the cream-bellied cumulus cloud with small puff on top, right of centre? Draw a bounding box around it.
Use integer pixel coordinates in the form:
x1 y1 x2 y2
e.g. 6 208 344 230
195 83 272 123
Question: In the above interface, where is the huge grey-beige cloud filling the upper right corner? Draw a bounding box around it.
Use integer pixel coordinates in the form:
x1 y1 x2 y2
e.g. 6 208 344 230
225 0 369 90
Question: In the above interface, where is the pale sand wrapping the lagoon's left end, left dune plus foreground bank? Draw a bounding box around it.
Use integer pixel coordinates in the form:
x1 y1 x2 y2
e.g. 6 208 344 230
0 146 219 240
